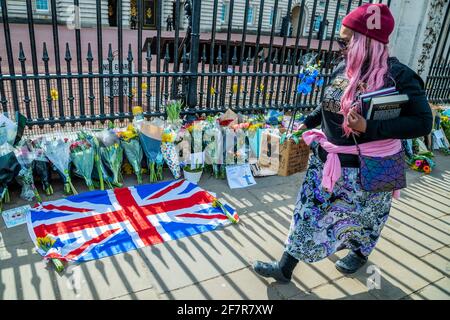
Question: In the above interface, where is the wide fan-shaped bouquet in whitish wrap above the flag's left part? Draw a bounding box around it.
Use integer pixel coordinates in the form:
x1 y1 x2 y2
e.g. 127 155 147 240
42 137 77 194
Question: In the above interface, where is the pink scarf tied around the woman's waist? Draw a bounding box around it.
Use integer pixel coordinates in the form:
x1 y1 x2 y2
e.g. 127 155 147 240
302 129 402 199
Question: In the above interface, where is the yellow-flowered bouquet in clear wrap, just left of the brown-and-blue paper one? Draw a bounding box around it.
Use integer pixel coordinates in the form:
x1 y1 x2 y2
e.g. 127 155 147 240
118 124 144 184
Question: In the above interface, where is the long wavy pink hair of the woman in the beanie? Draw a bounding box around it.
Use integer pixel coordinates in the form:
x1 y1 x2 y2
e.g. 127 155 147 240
340 32 389 137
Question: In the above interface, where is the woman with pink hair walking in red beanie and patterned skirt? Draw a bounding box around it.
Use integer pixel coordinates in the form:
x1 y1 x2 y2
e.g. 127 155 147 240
253 3 432 283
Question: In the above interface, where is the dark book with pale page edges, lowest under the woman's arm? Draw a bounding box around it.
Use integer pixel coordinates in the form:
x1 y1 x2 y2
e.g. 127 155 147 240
366 94 409 120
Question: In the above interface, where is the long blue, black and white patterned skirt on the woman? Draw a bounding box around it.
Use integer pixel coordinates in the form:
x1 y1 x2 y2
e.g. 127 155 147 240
285 150 392 262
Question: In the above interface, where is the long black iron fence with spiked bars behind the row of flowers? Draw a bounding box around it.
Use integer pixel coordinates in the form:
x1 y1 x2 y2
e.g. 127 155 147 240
0 0 398 128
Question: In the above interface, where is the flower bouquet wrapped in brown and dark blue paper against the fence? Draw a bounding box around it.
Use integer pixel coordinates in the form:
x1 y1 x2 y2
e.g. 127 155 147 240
139 119 164 182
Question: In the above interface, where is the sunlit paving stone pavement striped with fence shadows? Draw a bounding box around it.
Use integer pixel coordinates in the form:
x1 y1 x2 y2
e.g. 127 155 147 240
0 156 450 300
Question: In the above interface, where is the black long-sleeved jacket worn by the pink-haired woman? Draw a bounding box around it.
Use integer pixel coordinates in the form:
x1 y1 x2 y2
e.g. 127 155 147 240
304 58 433 167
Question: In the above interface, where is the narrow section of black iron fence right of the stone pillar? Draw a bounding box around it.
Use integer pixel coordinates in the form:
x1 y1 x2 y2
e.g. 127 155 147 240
426 0 450 103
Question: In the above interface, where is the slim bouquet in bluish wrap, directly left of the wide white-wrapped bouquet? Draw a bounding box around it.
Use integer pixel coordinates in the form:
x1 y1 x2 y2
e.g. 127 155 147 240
14 141 42 202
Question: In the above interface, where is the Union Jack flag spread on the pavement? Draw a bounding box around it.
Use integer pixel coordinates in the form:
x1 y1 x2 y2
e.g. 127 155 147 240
27 180 239 262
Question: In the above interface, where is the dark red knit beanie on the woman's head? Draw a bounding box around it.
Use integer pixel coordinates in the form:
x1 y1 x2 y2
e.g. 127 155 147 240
342 3 395 44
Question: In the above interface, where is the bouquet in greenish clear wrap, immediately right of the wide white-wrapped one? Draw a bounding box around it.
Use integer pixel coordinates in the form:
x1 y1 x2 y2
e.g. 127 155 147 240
70 133 95 190
